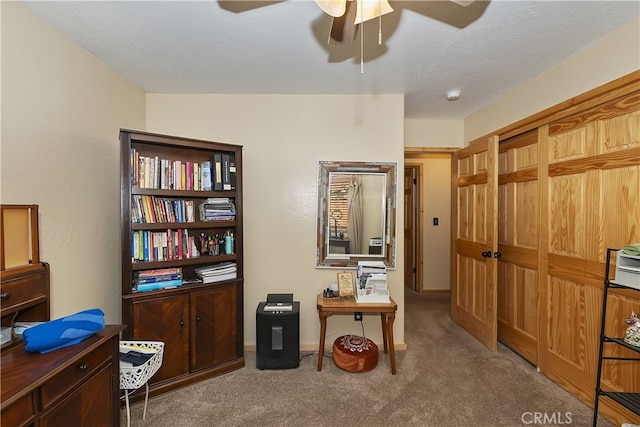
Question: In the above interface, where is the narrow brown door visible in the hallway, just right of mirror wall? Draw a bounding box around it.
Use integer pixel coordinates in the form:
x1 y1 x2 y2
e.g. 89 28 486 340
404 165 422 291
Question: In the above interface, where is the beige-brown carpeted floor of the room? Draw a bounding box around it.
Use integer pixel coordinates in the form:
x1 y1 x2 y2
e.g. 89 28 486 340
121 290 613 427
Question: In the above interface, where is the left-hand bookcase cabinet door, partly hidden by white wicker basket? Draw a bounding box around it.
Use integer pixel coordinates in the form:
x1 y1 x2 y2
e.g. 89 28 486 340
133 295 189 384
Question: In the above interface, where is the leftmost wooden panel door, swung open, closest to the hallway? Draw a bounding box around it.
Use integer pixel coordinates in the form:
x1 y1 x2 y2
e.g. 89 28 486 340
451 137 498 351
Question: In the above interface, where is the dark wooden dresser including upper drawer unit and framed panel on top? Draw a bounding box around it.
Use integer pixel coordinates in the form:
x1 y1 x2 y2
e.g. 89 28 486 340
0 205 125 427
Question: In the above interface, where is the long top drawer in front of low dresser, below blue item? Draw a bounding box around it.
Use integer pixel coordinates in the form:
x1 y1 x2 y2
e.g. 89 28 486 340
40 343 111 410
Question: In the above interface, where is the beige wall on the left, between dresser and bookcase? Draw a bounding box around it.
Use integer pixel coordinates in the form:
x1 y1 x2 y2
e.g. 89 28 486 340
0 1 145 323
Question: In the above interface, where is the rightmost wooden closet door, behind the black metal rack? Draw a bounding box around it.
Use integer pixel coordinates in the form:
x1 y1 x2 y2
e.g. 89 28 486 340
539 91 640 422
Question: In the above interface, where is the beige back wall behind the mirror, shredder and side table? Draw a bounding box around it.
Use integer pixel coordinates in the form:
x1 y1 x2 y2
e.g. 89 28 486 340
147 94 404 349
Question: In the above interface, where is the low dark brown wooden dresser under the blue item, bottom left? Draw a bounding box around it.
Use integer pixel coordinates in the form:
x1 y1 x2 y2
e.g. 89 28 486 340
1 325 124 427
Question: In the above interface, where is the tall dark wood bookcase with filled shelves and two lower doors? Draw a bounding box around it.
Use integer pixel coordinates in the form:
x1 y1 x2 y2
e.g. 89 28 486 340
120 129 244 401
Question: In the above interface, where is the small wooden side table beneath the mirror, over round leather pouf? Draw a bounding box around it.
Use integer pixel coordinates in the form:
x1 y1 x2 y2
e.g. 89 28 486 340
317 294 398 375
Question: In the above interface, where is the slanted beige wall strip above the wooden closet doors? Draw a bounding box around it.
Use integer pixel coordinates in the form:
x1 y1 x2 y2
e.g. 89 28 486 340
464 17 640 143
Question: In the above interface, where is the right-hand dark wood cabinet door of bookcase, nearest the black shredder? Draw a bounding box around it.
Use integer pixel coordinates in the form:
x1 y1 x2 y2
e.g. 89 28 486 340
191 284 238 371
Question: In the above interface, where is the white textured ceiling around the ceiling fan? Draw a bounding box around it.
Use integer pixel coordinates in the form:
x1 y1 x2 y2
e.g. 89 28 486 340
24 0 640 119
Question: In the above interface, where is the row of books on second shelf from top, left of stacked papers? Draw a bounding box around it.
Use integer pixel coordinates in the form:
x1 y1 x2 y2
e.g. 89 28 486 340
131 194 196 224
